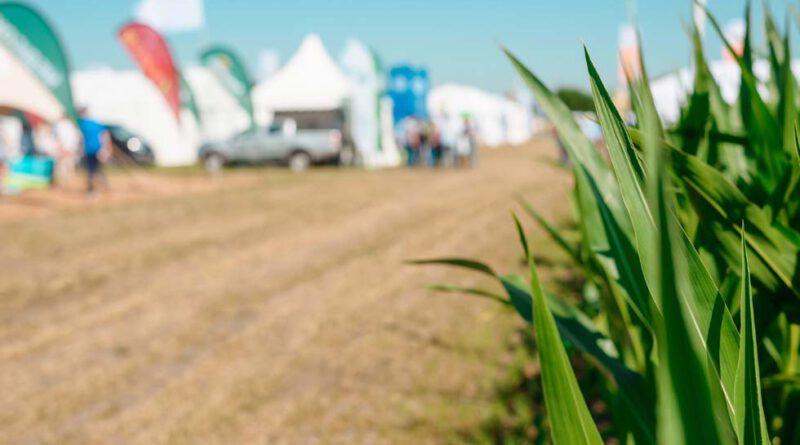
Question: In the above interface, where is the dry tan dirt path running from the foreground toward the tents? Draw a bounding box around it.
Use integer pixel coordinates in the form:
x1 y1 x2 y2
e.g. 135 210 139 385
0 138 567 445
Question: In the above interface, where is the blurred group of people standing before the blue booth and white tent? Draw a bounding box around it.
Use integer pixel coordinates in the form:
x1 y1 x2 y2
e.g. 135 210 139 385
398 116 478 168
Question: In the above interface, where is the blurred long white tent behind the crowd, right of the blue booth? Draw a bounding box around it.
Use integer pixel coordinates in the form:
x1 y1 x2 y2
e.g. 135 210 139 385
428 84 533 146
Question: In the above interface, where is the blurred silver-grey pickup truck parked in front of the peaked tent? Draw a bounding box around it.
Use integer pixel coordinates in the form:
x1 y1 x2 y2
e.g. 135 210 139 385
199 119 348 172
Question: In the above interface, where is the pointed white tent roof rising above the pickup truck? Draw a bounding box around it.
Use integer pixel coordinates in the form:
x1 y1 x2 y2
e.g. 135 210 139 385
253 34 352 111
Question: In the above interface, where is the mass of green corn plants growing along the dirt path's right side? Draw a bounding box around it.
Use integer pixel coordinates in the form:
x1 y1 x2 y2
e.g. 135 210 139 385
417 5 800 444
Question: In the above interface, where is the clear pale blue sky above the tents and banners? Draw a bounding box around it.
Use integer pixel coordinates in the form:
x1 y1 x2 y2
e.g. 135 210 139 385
29 0 797 92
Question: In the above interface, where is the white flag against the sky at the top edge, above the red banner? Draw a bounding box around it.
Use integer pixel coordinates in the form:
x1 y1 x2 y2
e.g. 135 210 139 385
134 0 205 33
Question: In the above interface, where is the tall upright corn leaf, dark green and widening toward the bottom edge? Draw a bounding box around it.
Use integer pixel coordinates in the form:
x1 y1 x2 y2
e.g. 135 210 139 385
643 100 725 444
